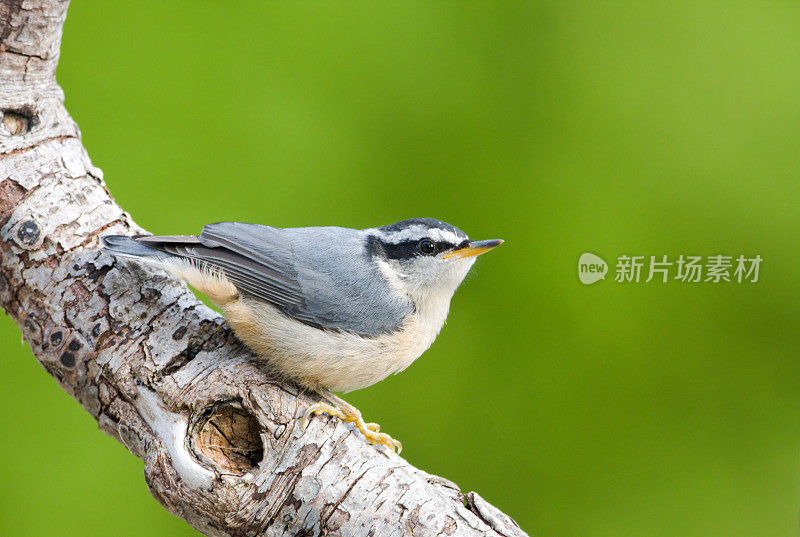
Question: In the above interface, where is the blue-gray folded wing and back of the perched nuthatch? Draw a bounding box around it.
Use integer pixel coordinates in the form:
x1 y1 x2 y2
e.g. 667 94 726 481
137 222 413 336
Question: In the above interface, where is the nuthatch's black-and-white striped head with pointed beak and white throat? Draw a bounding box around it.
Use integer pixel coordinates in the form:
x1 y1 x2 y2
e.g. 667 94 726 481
366 218 503 303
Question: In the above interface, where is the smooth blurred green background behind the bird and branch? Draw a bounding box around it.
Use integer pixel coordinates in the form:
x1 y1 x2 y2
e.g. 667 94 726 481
0 0 800 537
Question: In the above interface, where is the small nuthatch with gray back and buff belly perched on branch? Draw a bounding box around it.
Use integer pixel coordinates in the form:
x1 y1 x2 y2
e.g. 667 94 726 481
102 218 503 453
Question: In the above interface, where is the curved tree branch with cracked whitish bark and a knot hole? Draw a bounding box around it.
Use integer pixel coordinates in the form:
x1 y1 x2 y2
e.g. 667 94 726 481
0 0 525 537
